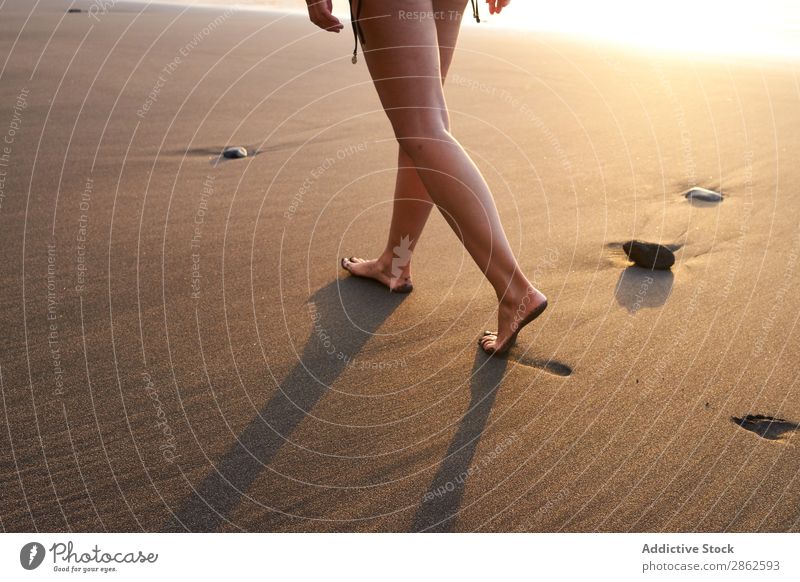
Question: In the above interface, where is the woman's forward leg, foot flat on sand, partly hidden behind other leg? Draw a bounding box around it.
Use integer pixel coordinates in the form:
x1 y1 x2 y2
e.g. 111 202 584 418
342 0 467 291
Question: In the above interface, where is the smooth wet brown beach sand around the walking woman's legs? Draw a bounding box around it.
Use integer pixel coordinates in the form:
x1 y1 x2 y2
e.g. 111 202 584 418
0 0 800 532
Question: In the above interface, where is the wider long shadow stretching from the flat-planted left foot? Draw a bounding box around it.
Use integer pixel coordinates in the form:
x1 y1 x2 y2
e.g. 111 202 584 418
163 278 405 532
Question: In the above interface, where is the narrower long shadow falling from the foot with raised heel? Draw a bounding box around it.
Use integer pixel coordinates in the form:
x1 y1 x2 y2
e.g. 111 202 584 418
413 349 508 532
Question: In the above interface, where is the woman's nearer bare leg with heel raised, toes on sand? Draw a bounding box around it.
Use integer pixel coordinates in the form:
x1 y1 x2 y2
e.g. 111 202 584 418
361 0 547 352
